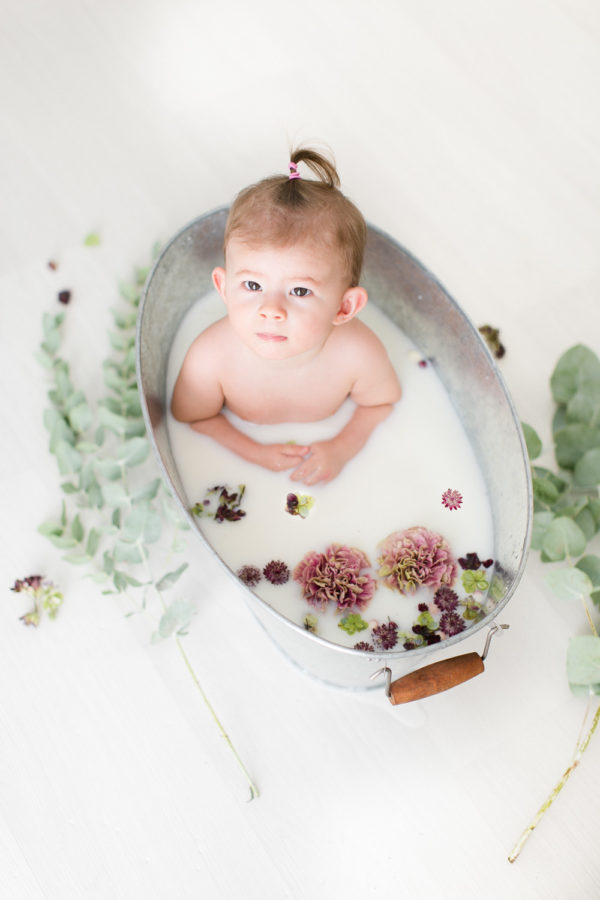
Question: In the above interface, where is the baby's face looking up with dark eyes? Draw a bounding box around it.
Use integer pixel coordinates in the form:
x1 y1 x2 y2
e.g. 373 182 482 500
213 238 352 360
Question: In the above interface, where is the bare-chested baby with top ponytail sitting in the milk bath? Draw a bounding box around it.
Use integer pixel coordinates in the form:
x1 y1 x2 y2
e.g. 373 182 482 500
171 148 401 484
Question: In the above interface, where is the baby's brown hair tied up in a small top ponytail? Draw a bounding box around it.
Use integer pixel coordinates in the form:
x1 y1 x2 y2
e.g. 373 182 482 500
225 147 367 287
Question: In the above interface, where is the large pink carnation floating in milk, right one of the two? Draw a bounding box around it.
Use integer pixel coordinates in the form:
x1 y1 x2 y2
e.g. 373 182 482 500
378 525 458 594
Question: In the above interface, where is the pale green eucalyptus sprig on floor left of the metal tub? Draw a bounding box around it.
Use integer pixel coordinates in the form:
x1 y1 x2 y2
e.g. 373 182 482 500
36 253 258 797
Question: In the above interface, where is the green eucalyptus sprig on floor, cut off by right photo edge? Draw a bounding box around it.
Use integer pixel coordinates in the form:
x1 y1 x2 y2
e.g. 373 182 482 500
509 345 600 862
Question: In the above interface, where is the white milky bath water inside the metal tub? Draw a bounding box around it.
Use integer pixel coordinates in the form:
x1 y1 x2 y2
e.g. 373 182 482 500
167 292 493 650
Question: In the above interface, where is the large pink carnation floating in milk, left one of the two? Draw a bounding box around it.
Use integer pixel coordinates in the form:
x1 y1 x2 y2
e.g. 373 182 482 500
294 544 377 610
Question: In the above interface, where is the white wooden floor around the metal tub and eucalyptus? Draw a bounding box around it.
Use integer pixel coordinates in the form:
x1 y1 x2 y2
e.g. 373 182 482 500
0 0 600 900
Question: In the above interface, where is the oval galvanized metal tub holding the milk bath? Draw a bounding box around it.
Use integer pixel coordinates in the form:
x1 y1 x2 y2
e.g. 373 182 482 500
137 209 532 702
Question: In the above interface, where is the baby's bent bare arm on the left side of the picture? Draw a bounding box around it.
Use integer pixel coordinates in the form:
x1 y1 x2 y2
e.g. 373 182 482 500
171 322 309 472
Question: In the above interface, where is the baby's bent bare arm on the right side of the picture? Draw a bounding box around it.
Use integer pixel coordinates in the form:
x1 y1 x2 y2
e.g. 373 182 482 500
291 332 402 484
